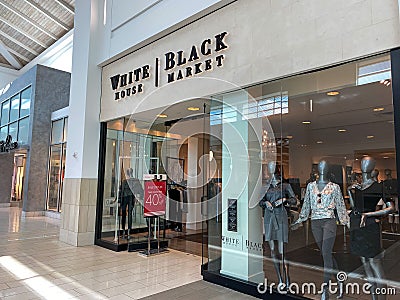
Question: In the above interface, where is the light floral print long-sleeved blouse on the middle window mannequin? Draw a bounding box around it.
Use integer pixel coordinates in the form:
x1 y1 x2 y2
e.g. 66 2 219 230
295 181 349 225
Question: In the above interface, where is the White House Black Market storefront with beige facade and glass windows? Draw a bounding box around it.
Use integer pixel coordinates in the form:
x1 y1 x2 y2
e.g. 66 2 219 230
96 1 400 298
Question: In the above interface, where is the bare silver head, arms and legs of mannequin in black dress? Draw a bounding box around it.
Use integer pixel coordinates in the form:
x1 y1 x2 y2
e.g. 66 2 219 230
348 156 394 300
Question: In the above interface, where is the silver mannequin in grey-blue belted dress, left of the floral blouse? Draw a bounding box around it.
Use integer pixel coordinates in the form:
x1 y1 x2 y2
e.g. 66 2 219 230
259 161 297 287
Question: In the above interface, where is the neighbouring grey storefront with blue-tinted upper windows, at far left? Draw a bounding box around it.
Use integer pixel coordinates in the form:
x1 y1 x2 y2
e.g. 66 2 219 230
0 65 70 216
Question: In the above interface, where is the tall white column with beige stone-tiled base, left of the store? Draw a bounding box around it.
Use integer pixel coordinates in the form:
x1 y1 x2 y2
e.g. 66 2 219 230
60 0 108 246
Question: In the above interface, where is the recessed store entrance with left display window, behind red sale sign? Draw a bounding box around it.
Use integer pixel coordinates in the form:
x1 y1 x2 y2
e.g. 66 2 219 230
98 99 219 256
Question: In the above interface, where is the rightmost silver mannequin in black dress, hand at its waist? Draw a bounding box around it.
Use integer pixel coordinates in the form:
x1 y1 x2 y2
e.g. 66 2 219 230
348 156 394 299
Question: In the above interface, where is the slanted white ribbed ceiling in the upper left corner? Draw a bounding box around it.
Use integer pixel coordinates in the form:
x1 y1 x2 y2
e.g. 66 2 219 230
0 0 75 70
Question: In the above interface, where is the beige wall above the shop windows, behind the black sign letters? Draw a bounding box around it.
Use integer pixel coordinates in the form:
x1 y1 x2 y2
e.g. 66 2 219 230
101 0 400 121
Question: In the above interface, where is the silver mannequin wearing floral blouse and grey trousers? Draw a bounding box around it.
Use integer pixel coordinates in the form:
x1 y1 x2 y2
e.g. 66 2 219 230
292 160 349 299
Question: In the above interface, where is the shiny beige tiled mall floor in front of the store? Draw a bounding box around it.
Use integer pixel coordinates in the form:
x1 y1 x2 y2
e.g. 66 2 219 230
0 208 253 300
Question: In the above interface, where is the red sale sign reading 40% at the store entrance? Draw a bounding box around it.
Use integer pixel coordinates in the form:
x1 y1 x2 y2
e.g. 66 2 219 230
144 180 167 217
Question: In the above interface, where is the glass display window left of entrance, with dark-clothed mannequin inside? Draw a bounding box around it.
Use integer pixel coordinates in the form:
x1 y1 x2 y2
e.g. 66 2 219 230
101 119 174 248
